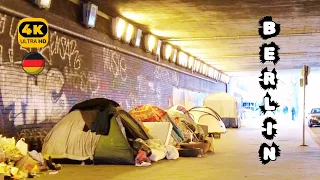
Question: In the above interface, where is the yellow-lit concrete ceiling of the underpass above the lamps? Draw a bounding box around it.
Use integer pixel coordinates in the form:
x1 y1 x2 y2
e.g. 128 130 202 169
87 0 320 75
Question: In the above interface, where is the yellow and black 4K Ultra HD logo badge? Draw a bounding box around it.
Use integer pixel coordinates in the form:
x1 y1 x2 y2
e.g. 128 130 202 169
18 18 49 48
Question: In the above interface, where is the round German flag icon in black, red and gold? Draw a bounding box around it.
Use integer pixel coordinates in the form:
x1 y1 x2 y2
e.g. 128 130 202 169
22 52 45 75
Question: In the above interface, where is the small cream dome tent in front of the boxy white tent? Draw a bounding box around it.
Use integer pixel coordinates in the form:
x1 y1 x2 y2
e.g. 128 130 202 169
189 107 226 133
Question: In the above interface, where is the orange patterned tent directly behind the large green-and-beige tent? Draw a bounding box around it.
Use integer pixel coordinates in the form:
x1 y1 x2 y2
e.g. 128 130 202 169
129 104 184 143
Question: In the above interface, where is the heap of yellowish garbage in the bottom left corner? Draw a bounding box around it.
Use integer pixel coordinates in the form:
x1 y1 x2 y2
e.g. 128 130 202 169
0 135 61 180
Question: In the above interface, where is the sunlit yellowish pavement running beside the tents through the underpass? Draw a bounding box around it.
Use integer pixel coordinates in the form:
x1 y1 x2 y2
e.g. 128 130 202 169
37 123 320 180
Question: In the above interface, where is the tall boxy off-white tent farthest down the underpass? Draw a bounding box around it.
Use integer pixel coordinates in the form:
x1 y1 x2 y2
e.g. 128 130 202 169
203 92 240 128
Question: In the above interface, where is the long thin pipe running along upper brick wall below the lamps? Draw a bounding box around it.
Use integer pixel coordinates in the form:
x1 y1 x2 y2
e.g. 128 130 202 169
0 6 217 83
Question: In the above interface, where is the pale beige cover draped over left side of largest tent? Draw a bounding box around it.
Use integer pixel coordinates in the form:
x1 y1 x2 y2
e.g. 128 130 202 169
42 111 101 161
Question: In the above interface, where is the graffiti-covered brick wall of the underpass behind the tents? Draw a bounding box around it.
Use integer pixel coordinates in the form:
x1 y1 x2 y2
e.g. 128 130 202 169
0 0 226 145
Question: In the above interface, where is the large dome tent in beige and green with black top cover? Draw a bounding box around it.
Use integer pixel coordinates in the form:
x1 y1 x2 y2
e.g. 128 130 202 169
42 98 150 164
